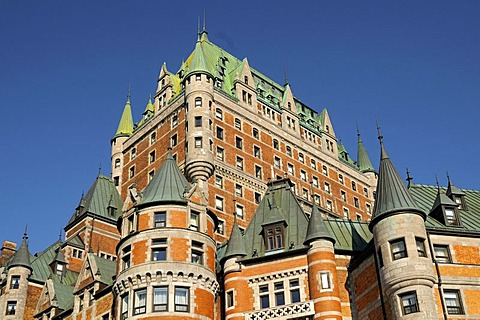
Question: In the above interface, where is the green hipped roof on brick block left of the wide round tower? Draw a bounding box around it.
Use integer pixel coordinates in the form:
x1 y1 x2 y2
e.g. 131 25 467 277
68 174 123 224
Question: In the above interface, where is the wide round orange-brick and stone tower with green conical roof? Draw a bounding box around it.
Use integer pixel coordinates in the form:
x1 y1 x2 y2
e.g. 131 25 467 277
113 150 218 319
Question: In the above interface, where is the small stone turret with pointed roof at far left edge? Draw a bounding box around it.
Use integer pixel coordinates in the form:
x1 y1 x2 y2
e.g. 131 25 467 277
0 231 33 319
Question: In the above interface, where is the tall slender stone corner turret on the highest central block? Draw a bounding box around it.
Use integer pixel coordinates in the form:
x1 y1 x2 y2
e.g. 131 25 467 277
183 33 214 187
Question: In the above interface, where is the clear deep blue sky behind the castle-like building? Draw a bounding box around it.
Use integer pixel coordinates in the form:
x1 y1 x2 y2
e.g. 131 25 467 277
0 0 480 252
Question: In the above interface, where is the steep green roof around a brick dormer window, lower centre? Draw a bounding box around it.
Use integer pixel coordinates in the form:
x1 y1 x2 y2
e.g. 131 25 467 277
244 179 308 257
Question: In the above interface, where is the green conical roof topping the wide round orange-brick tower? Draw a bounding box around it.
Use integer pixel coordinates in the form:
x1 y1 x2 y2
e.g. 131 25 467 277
140 150 191 206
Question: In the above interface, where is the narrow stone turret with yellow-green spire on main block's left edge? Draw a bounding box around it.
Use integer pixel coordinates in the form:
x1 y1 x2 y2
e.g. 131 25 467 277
110 89 133 193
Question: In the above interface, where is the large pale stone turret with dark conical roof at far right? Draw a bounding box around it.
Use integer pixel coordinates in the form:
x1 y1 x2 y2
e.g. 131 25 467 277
369 134 438 319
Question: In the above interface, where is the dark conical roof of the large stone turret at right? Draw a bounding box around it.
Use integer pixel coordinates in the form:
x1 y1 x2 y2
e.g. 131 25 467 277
370 137 426 230
